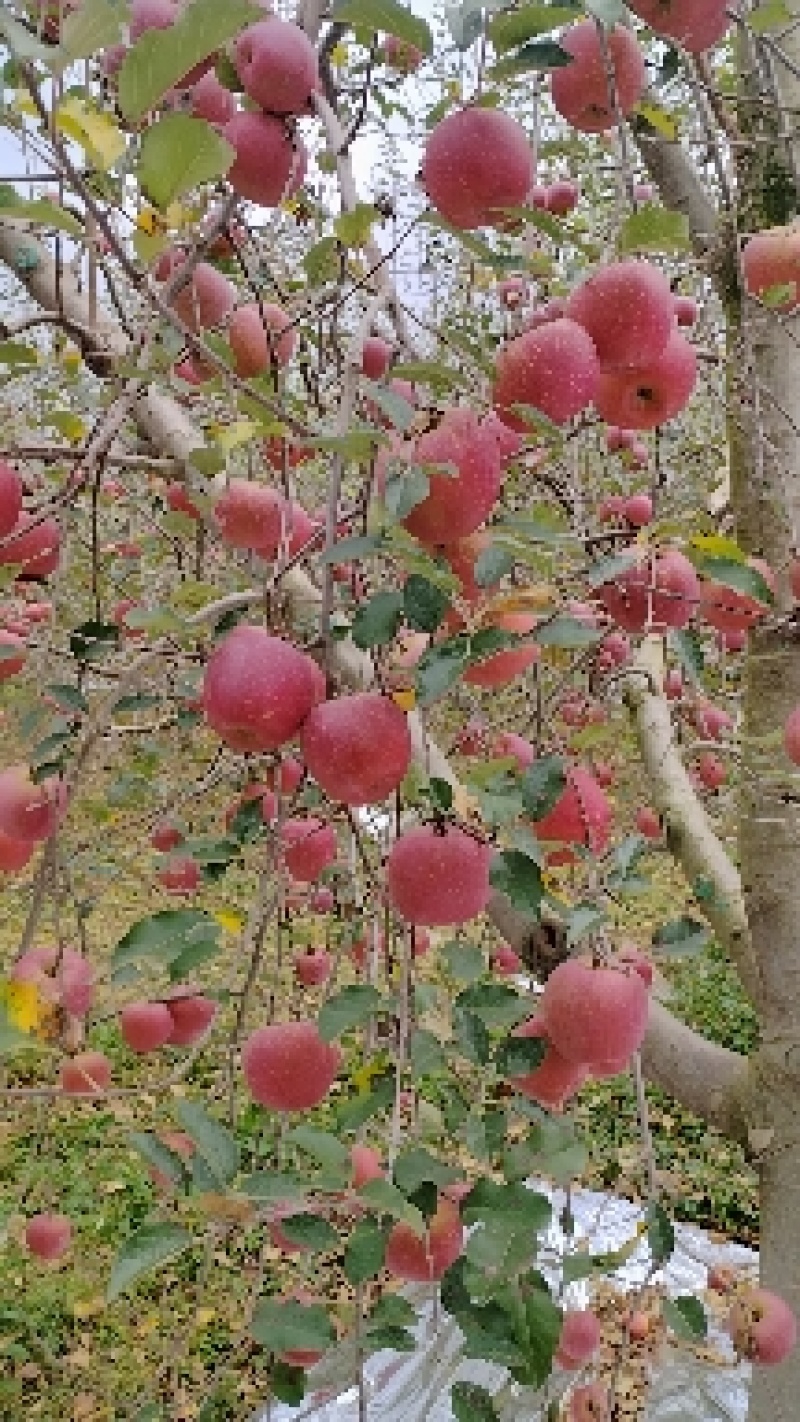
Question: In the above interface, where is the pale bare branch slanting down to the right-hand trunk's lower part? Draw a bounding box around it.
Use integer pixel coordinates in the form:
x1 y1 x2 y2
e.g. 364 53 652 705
625 637 760 1003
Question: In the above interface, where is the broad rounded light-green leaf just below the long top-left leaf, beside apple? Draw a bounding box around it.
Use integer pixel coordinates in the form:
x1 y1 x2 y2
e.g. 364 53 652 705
138 114 236 209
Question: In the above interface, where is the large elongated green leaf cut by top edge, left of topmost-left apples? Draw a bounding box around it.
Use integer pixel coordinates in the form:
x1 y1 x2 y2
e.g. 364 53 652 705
118 0 264 122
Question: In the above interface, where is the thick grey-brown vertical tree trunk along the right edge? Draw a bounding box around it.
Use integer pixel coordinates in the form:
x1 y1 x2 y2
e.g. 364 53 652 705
729 8 800 1422
